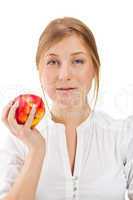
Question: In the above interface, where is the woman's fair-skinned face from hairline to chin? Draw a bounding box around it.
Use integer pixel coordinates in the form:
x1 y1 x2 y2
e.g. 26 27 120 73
39 35 94 108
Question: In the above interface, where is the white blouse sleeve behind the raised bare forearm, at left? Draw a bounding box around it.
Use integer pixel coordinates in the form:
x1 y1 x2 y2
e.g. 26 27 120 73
0 131 28 199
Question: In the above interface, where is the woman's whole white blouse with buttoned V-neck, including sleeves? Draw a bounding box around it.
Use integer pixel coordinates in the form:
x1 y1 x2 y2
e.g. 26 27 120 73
0 110 133 200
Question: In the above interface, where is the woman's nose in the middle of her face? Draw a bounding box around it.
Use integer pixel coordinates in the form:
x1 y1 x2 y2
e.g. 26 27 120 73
59 63 71 79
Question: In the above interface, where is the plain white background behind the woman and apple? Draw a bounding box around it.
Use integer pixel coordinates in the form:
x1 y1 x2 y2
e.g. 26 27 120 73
0 0 133 198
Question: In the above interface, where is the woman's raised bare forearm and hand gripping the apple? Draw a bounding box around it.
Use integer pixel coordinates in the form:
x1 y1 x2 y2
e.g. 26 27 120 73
2 97 45 200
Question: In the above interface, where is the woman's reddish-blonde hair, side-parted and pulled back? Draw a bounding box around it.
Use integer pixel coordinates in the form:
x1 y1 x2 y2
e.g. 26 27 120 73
36 17 100 108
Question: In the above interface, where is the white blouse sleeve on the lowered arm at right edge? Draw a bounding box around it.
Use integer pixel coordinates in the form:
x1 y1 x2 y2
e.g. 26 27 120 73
122 115 133 199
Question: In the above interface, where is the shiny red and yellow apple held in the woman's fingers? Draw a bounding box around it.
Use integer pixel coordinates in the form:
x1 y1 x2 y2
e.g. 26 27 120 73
14 94 45 128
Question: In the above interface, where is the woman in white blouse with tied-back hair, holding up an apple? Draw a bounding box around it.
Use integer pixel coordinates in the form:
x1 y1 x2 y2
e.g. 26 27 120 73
0 17 133 200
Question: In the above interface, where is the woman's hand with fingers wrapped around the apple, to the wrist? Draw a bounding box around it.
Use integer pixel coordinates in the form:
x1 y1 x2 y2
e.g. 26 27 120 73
2 101 45 151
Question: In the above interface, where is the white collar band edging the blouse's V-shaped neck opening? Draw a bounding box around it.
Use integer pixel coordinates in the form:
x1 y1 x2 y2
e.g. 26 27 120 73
47 110 94 179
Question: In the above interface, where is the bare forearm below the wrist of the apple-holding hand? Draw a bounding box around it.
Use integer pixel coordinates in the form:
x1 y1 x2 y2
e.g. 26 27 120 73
3 149 45 200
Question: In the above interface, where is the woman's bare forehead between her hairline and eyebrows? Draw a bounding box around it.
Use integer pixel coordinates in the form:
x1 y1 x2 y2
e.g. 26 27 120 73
45 35 88 56
